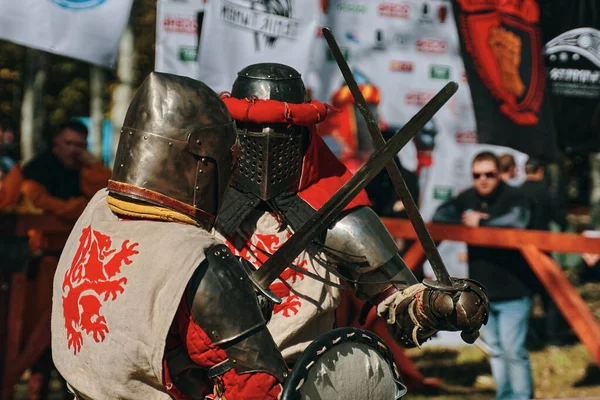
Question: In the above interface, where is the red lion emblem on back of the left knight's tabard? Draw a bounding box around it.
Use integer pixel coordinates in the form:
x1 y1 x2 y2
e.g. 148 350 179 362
62 226 138 354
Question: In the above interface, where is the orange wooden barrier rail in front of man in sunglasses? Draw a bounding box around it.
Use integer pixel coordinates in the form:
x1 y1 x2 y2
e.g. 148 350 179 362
382 218 600 365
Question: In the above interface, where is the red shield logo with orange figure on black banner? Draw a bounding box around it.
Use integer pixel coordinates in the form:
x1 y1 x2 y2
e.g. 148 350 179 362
458 0 545 125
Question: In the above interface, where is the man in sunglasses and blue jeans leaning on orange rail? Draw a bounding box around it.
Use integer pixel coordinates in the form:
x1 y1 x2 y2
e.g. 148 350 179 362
433 152 536 400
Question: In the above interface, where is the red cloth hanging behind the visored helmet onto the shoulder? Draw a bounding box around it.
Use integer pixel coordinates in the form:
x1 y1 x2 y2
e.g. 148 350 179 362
298 126 371 210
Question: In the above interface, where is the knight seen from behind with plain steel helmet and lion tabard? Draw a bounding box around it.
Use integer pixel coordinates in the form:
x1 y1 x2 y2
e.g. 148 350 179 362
52 73 288 399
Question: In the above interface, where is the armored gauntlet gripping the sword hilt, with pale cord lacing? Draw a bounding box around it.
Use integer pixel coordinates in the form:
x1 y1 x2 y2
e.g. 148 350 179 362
377 279 489 347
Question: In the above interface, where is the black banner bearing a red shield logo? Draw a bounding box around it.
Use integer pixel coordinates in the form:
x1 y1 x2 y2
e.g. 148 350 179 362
453 0 558 160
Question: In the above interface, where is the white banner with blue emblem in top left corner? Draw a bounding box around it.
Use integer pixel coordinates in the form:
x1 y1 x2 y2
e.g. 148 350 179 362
0 0 133 67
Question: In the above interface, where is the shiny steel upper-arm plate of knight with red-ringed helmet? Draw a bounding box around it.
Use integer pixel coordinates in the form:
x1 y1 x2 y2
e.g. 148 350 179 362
325 207 418 300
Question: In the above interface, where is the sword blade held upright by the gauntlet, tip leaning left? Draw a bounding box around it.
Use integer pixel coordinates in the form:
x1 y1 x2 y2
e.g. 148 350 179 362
323 28 453 289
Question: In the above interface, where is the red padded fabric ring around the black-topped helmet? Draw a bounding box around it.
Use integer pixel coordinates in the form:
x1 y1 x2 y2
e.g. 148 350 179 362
221 93 332 126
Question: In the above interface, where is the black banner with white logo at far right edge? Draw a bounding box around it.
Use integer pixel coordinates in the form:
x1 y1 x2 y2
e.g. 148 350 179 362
542 0 600 155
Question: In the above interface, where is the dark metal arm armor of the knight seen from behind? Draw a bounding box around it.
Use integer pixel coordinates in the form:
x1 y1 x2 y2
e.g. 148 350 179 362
167 241 288 396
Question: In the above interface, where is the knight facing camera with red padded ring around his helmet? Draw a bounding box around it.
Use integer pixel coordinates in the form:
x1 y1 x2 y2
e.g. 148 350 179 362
217 63 487 364
